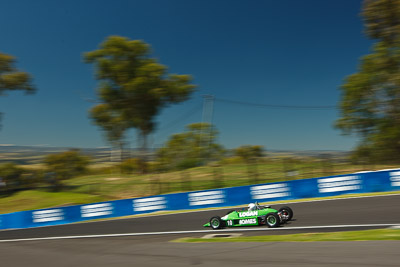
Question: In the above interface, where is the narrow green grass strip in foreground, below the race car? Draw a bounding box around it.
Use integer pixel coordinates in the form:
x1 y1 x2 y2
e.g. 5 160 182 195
172 229 400 243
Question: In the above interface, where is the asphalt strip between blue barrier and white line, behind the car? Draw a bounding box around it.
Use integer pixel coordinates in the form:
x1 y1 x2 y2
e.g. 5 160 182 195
0 195 400 240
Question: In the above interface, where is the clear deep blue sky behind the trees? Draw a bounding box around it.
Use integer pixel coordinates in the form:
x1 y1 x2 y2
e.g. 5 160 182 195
0 0 372 150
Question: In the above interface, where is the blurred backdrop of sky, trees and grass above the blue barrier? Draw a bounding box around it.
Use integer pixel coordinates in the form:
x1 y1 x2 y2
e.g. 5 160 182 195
0 0 400 213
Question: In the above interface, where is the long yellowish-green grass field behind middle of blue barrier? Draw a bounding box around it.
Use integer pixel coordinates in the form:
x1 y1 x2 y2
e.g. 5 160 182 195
65 161 396 199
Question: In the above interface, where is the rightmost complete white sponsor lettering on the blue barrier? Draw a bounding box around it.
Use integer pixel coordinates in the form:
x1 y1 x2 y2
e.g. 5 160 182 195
317 175 362 193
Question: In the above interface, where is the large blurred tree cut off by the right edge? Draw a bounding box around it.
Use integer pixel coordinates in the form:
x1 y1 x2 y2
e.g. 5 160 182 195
336 0 400 161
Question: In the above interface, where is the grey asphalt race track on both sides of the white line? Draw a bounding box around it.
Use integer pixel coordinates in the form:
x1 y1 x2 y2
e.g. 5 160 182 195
0 195 400 266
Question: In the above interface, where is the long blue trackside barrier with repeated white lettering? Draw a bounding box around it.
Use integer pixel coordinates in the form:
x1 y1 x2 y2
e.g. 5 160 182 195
0 169 400 229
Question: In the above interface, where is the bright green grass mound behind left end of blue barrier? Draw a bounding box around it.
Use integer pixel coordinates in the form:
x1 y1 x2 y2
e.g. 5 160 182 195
0 190 103 213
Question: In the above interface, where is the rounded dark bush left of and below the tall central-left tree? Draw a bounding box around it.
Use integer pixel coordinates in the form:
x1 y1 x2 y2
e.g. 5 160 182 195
44 150 89 190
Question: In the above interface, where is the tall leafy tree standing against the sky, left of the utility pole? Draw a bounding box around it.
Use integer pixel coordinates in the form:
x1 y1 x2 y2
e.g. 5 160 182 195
84 36 195 172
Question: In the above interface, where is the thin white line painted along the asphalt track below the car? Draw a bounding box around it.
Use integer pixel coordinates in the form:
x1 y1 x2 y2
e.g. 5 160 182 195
0 223 400 243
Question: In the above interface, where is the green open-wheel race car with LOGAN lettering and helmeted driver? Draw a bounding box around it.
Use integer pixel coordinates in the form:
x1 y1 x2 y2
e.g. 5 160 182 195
203 202 293 230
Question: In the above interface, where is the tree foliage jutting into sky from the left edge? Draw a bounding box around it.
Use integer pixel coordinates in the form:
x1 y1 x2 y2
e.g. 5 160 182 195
0 52 35 130
